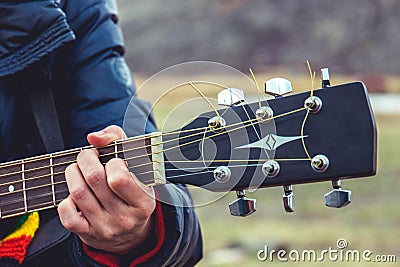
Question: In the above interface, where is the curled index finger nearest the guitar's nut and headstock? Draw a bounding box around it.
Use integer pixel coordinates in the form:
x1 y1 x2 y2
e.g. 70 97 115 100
106 158 154 207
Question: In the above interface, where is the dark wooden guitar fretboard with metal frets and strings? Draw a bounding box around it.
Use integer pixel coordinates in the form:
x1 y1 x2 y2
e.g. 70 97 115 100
0 135 161 219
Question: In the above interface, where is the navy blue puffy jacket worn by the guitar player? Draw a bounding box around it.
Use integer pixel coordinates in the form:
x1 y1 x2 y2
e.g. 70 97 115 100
0 0 202 267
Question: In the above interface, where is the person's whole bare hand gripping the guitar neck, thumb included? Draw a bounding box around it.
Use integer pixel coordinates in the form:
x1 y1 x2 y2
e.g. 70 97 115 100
58 126 156 254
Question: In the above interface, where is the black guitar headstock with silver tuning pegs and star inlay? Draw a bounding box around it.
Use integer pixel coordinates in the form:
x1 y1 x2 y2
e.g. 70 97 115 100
137 70 377 216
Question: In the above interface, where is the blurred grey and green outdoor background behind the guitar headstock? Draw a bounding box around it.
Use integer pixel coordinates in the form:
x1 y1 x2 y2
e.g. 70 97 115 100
118 0 400 266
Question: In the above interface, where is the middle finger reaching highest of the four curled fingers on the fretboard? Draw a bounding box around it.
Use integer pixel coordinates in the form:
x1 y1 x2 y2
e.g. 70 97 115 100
77 149 119 211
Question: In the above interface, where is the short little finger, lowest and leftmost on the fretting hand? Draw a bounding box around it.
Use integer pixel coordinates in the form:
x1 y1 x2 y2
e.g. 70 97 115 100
57 197 89 234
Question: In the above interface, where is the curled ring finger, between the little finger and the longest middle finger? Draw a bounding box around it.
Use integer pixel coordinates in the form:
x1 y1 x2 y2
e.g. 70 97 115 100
65 163 102 218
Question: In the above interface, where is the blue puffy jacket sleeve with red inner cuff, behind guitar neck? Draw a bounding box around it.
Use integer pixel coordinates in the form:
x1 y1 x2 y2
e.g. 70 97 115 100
53 1 202 266
